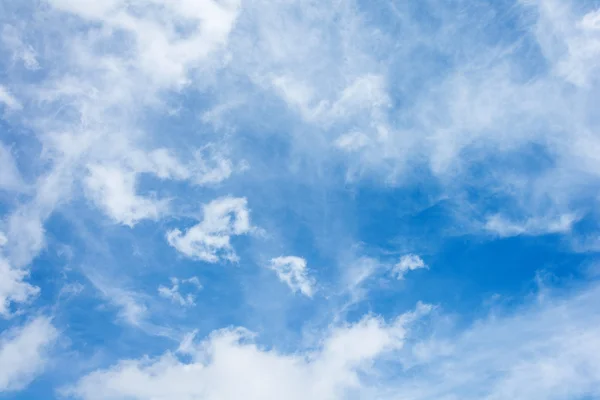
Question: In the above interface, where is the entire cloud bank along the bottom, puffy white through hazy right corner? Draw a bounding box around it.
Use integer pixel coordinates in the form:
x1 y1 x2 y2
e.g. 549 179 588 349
66 287 600 400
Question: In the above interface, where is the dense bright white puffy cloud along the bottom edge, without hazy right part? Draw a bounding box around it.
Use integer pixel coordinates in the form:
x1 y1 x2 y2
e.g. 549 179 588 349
65 306 429 400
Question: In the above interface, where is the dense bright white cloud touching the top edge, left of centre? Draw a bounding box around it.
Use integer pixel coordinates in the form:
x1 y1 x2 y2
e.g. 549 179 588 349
50 0 239 88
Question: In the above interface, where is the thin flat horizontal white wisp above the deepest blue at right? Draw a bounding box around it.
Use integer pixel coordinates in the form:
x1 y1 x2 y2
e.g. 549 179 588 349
485 214 579 237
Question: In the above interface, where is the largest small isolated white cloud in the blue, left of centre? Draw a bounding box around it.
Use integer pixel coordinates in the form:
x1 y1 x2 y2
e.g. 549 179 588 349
167 197 252 263
